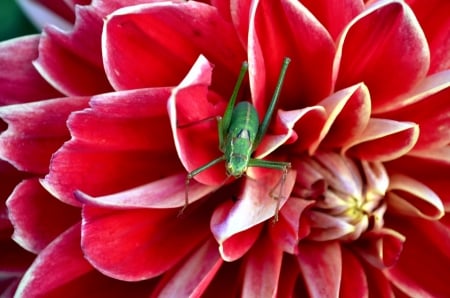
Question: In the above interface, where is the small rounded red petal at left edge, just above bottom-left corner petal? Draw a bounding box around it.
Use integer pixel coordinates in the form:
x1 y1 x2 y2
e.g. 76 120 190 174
6 179 80 253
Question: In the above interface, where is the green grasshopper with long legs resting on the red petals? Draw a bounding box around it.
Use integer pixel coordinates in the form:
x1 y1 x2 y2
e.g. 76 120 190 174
181 57 291 221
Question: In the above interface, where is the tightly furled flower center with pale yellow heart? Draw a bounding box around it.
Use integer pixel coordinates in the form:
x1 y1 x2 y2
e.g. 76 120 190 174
294 152 389 241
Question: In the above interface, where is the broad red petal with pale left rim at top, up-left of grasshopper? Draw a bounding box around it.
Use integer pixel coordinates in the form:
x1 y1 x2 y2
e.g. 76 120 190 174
103 2 245 90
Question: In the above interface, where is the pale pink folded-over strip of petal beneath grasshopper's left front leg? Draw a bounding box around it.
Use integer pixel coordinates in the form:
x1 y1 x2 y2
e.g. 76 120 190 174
75 174 214 209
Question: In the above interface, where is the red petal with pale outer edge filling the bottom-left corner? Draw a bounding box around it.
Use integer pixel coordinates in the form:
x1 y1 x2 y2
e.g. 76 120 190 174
16 224 156 297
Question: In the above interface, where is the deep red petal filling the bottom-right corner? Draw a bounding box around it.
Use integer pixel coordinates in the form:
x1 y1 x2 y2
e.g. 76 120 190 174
385 217 450 297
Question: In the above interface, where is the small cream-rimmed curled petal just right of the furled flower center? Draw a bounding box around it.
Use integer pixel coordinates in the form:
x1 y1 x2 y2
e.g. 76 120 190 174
386 174 444 220
